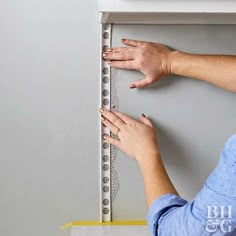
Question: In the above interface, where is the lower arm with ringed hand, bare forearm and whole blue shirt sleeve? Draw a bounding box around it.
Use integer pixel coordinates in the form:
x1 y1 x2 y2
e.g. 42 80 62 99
101 109 236 236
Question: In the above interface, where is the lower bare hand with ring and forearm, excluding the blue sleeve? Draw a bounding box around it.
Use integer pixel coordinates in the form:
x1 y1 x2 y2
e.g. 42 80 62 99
100 109 178 207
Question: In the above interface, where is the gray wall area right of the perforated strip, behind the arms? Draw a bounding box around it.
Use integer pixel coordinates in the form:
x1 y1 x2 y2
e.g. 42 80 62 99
112 25 236 220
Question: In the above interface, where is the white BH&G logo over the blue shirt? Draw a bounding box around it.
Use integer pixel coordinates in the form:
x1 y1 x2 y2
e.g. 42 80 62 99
206 206 232 233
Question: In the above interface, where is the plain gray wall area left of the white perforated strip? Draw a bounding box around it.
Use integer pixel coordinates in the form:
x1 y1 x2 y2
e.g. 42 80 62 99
0 0 99 236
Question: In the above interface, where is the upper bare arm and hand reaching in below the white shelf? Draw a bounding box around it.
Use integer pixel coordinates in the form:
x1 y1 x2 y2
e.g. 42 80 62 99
103 39 236 92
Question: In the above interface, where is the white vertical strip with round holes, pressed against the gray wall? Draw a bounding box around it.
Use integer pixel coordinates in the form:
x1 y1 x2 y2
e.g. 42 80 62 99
100 24 112 222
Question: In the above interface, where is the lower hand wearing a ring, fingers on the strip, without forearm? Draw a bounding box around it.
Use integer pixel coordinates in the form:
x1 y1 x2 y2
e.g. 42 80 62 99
100 109 160 161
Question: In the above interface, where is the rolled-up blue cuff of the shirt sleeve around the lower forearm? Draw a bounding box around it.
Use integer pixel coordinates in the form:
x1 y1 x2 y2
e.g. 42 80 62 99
146 193 187 236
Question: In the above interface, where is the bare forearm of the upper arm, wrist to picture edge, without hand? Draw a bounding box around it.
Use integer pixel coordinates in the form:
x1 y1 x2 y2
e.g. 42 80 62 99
171 51 236 92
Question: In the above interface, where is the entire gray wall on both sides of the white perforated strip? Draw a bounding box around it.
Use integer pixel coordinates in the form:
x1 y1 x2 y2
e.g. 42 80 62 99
0 0 236 236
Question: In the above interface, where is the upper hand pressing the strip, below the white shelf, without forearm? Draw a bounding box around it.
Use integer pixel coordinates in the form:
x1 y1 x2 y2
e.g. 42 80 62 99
103 39 173 88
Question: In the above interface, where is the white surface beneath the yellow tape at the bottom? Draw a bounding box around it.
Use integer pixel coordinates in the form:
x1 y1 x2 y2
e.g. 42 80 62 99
70 225 151 236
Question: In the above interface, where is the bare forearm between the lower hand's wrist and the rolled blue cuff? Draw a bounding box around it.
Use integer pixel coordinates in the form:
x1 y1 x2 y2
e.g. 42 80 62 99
137 154 178 207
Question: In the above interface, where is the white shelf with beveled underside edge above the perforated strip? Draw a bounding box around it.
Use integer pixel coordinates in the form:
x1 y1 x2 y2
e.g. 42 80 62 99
99 0 236 24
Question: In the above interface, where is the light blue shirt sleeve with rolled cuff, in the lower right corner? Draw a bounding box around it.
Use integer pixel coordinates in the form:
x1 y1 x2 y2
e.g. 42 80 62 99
147 135 236 236
